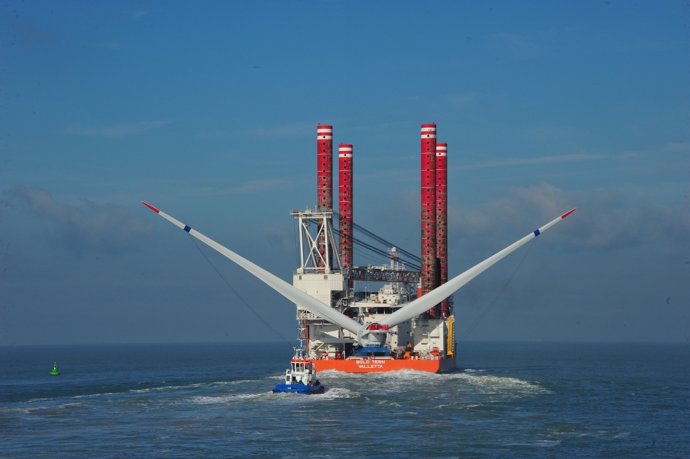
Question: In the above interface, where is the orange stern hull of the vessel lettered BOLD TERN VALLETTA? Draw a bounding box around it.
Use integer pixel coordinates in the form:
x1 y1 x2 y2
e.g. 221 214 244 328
312 357 455 373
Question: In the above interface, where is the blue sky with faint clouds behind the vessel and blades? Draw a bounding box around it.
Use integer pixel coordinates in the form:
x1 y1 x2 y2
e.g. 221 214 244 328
0 0 690 345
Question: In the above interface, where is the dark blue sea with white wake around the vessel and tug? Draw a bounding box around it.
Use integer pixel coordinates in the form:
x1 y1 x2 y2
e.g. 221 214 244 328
0 343 690 458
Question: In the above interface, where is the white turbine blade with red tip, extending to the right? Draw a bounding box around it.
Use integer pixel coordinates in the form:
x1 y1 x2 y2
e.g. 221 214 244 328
380 209 575 327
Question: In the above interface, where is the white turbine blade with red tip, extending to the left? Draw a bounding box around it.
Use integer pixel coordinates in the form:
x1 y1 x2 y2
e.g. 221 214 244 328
143 202 362 333
